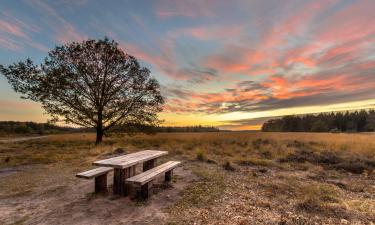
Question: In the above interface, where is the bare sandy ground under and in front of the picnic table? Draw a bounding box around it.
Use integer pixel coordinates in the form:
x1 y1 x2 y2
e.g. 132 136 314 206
0 167 194 225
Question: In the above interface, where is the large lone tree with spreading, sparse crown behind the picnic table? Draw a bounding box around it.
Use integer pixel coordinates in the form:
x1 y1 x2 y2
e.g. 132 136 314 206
0 38 164 144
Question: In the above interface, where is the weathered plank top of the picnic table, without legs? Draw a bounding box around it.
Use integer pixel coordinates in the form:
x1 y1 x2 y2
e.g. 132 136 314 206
93 150 168 169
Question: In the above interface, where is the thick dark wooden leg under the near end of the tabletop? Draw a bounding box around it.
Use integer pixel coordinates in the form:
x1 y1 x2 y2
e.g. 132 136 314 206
113 166 135 196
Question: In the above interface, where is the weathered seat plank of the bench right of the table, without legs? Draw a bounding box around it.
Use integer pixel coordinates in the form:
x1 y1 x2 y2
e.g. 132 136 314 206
126 161 181 185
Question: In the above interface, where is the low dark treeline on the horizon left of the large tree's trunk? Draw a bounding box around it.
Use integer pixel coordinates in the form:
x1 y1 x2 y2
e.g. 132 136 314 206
0 121 85 135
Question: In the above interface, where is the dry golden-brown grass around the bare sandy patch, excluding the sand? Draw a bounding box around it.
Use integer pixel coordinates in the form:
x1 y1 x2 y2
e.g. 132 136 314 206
0 132 375 224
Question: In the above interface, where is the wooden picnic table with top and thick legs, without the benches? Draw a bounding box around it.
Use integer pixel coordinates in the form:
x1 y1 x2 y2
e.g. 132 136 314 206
93 150 168 196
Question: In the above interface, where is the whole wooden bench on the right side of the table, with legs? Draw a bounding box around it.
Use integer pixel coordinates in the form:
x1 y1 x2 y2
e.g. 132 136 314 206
126 161 181 198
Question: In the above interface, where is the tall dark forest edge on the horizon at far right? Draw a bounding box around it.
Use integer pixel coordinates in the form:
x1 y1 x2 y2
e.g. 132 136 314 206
262 109 375 132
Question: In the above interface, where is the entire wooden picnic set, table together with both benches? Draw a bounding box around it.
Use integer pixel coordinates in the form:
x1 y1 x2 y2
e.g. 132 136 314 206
76 150 180 197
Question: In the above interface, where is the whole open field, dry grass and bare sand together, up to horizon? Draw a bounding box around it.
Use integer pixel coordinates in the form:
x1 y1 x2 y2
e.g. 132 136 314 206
0 132 375 224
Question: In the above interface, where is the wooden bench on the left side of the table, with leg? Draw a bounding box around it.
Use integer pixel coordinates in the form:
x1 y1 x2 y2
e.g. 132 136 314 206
76 167 113 193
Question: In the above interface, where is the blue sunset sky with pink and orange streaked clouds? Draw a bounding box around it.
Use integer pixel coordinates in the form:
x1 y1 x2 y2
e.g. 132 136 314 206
0 0 375 130
